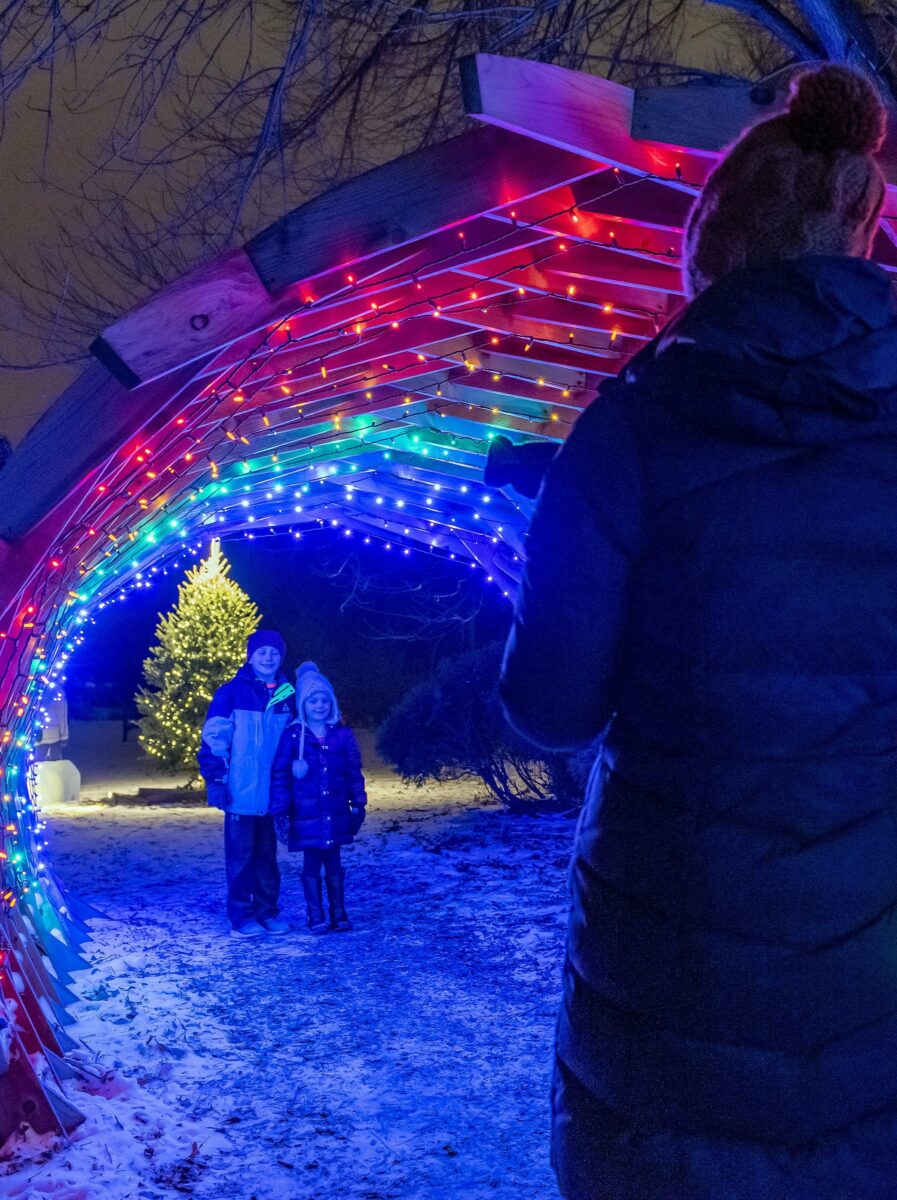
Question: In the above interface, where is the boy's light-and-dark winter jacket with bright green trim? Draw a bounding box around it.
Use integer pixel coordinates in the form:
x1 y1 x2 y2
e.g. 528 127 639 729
197 664 294 817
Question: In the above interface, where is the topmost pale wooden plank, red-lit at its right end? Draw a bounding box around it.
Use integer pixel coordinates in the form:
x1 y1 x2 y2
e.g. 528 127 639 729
460 54 712 192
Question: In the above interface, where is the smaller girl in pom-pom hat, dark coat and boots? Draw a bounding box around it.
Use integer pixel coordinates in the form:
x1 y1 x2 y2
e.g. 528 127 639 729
271 662 367 934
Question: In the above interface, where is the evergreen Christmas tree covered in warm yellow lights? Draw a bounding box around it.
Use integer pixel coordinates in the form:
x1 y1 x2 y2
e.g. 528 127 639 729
134 541 261 773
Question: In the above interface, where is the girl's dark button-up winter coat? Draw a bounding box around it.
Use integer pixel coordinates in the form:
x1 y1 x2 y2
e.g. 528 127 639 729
271 721 367 850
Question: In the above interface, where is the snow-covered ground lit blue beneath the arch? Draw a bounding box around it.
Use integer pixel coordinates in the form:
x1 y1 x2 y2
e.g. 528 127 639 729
0 724 573 1200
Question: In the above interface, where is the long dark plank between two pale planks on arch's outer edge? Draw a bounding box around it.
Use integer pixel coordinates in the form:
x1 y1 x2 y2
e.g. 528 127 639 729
246 128 597 292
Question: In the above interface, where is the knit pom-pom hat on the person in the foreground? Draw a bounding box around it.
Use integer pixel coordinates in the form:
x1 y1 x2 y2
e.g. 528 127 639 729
684 66 885 298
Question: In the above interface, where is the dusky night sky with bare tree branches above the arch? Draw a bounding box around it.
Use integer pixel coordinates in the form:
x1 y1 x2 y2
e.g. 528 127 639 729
0 0 897 439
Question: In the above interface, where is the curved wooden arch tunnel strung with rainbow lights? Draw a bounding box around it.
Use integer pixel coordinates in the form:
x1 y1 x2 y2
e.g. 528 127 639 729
0 55 897 1142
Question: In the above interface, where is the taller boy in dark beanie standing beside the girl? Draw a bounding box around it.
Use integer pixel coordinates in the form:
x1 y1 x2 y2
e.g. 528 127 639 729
197 629 294 937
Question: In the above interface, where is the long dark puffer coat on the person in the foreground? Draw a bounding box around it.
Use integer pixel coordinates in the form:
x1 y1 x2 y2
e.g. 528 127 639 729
501 258 897 1200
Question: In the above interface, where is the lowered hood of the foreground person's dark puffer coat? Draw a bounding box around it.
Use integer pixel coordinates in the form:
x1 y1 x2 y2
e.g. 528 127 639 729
618 257 897 445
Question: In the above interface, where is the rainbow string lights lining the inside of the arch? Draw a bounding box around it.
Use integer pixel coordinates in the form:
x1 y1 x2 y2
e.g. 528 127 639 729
0 162 678 926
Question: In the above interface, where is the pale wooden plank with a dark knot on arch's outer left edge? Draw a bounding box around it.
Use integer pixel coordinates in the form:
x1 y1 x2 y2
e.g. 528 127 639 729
91 250 284 388
